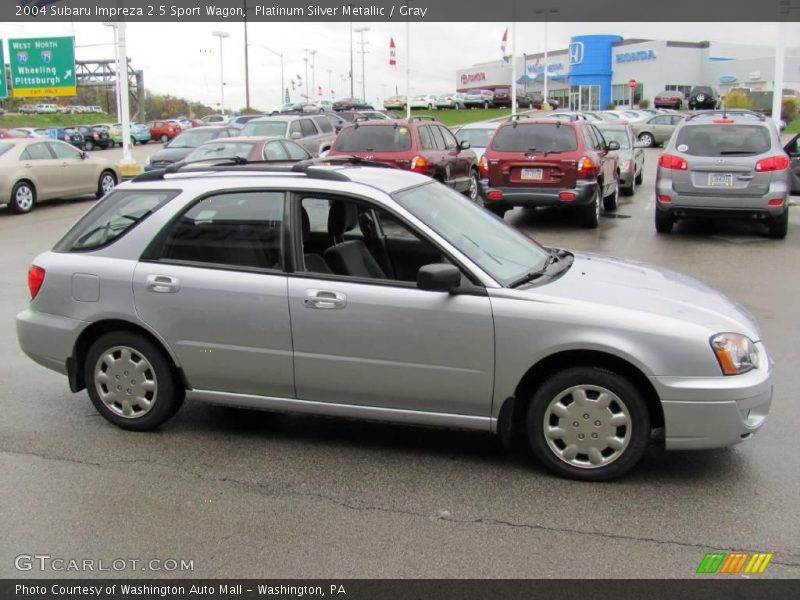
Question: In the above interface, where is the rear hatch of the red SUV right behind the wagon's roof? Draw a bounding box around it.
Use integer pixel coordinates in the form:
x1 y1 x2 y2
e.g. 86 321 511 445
328 122 415 169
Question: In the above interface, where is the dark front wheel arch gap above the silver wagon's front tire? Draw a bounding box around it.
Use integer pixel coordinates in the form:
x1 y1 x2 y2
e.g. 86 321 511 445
497 349 664 442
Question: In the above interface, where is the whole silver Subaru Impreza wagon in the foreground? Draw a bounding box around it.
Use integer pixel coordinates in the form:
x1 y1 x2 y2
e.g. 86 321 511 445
17 158 772 480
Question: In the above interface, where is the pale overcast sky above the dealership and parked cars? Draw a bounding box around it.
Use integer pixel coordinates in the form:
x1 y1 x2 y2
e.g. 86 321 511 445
0 22 800 109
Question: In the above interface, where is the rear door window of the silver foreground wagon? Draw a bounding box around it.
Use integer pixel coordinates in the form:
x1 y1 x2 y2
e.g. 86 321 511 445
160 191 284 269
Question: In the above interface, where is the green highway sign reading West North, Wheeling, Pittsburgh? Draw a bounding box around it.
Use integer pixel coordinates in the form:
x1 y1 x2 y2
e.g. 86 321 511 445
8 37 77 98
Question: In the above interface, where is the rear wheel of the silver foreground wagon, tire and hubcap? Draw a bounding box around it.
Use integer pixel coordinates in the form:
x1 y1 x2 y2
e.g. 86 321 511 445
84 331 184 431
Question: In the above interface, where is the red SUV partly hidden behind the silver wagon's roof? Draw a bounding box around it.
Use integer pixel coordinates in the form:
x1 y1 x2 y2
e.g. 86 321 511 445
328 117 479 202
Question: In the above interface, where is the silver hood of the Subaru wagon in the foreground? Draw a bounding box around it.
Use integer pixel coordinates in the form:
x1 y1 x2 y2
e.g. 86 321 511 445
526 253 760 341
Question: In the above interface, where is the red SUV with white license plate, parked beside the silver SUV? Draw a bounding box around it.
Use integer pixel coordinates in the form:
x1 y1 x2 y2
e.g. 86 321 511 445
480 116 619 228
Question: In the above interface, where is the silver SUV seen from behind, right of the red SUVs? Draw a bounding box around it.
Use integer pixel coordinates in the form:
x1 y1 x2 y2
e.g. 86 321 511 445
655 110 790 238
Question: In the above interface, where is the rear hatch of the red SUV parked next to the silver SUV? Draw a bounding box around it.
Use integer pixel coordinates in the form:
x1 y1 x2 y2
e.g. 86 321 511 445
484 121 579 189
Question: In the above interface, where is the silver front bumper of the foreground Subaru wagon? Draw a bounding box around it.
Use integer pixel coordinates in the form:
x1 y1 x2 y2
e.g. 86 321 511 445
650 343 772 450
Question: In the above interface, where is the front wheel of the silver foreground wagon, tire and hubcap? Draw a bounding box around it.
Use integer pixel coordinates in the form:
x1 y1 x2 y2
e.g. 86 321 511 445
526 367 650 481
